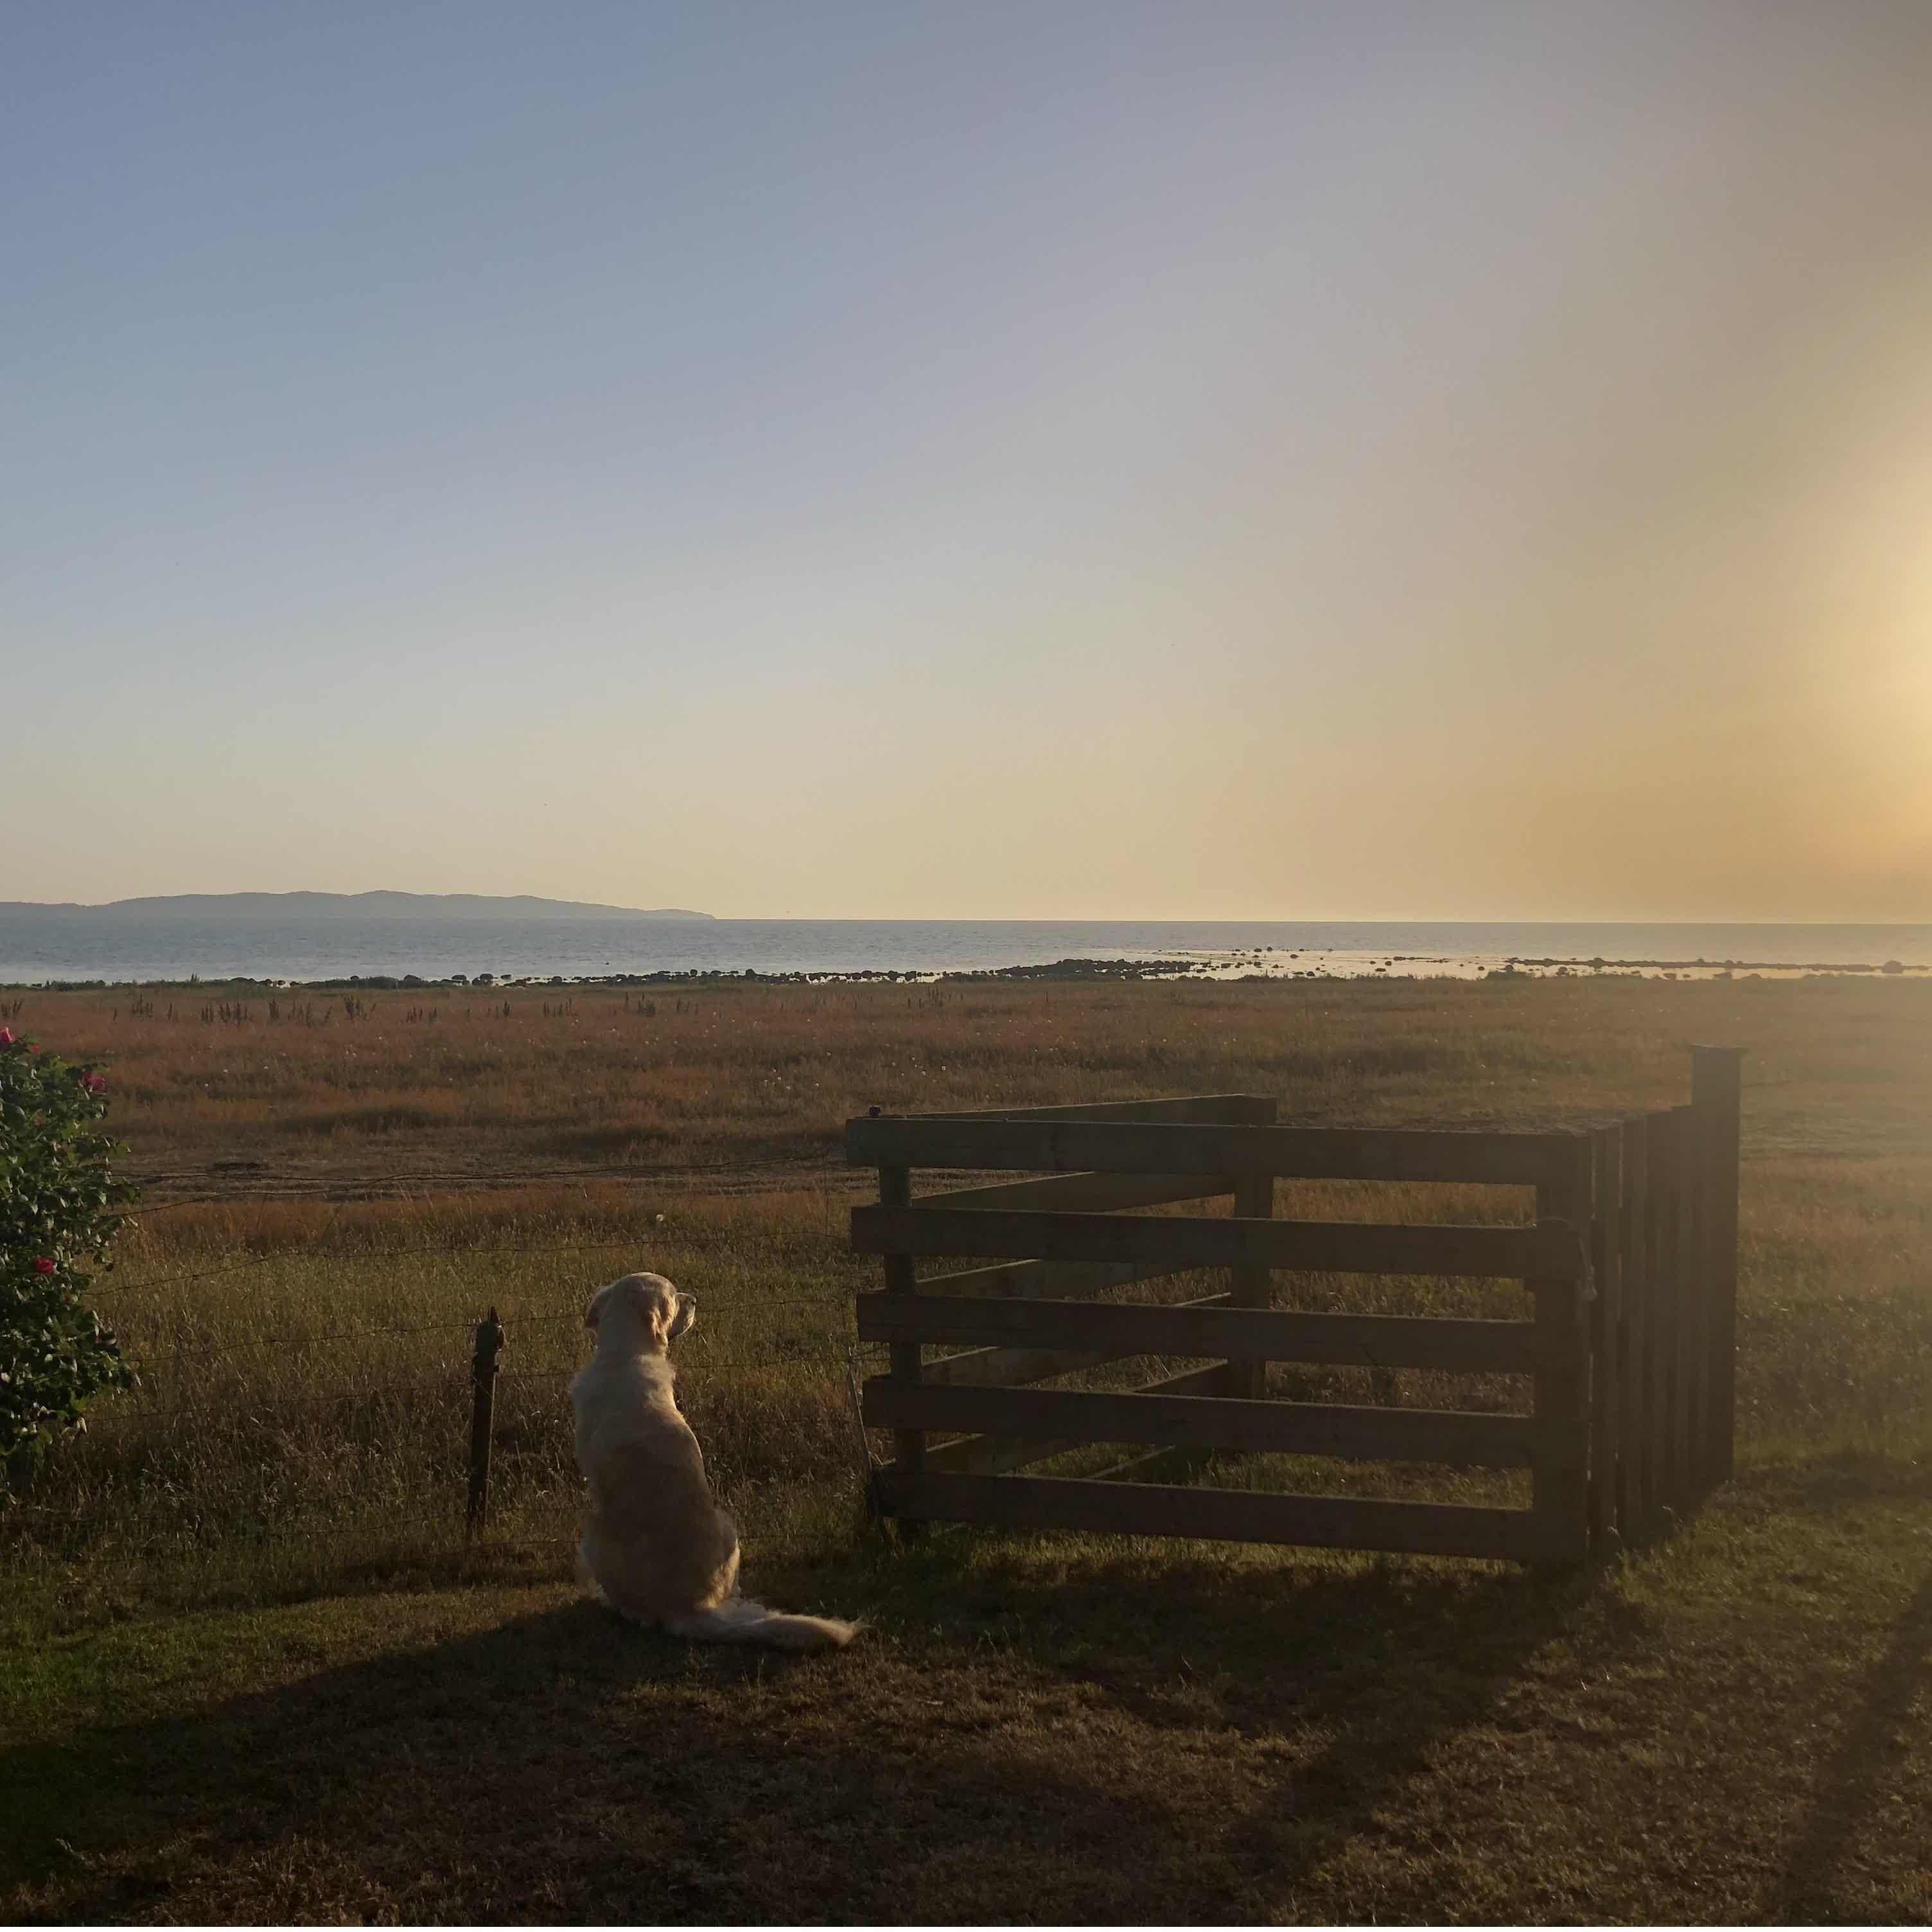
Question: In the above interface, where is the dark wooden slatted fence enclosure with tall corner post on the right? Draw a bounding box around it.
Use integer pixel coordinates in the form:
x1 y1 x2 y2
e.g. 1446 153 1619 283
847 1047 1739 1563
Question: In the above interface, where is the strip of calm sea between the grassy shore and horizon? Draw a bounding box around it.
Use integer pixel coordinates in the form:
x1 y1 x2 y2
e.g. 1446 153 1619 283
0 912 1932 983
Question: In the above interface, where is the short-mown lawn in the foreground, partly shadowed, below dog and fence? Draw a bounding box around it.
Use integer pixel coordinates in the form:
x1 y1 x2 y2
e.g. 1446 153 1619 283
0 1464 1932 1922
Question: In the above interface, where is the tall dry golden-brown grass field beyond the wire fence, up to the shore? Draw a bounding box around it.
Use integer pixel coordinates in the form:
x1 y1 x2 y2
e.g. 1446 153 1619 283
10 979 1932 1577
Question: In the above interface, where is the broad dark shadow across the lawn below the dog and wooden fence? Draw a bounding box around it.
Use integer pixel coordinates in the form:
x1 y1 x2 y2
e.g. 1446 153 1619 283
0 1532 1575 1922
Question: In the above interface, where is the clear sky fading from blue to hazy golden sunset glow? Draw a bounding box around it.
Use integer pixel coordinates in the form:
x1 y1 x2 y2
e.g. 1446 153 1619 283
0 0 1932 920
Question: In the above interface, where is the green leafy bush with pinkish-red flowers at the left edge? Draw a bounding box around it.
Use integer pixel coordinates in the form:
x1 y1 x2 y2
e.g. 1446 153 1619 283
0 1026 137 1470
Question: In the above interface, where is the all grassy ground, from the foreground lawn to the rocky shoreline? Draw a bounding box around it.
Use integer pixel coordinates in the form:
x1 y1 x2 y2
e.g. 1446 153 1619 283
0 976 1932 1920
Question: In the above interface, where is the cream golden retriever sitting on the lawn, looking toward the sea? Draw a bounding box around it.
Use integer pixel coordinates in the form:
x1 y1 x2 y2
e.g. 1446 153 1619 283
570 1275 858 1650
